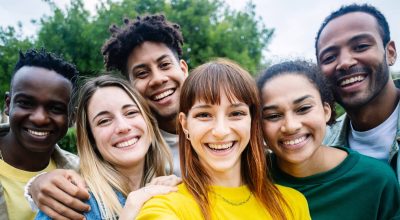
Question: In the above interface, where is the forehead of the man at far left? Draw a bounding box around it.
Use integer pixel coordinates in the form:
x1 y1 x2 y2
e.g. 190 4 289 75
11 66 72 102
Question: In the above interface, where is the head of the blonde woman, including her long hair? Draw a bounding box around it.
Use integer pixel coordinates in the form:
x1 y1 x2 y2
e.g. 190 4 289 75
76 75 172 218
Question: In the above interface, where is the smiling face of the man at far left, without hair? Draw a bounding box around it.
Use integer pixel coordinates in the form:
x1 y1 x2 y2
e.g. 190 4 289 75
5 66 72 152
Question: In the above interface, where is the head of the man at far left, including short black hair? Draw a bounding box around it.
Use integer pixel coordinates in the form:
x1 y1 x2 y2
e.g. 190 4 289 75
5 49 78 152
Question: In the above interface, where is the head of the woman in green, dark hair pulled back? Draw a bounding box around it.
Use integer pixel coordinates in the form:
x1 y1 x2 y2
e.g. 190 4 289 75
257 60 335 169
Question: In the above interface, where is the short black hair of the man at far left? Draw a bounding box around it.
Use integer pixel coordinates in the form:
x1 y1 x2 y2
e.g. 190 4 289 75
11 48 79 88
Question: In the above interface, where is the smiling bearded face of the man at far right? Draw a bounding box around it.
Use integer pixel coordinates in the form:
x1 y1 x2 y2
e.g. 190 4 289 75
317 12 396 109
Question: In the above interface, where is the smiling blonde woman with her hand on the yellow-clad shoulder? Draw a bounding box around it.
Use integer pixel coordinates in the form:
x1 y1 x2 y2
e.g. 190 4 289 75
37 75 180 219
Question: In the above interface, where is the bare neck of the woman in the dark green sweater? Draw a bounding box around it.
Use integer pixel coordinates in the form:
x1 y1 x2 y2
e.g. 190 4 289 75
278 146 347 178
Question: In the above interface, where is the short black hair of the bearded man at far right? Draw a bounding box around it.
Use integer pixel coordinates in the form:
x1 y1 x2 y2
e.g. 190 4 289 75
315 4 390 59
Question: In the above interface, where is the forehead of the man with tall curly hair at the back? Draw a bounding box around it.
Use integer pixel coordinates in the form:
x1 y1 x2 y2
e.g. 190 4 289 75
128 41 174 68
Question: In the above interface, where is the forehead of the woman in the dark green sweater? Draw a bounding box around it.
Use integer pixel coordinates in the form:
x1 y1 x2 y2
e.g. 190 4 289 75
261 73 320 103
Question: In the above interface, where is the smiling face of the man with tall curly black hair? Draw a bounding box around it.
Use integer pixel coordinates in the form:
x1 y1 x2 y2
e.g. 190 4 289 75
127 41 188 123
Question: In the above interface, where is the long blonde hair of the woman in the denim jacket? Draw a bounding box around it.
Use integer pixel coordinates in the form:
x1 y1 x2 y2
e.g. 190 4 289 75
76 75 173 219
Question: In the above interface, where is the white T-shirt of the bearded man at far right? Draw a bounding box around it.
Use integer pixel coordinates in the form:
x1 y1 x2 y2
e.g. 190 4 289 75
349 105 399 162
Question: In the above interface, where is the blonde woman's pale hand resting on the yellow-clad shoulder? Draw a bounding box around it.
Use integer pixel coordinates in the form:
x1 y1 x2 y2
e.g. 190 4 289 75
119 184 178 220
